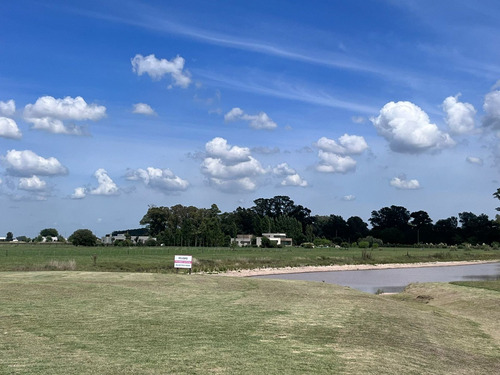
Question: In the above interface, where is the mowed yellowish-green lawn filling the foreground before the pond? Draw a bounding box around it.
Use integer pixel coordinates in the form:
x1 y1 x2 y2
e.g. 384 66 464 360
0 271 500 375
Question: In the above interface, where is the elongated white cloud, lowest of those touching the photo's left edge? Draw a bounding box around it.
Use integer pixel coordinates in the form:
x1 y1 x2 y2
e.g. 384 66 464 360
1 150 68 176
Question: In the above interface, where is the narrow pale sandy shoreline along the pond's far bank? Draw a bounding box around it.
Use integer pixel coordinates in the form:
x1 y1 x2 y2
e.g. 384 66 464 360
218 260 500 277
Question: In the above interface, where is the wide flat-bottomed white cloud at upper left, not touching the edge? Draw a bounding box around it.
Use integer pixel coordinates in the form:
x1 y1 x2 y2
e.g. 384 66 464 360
24 96 106 135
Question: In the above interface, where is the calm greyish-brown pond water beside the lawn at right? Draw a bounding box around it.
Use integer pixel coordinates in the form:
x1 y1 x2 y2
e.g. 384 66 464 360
255 263 500 293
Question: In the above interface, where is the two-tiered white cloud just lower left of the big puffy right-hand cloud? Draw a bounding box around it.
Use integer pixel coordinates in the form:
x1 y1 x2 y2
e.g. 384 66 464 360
316 134 368 173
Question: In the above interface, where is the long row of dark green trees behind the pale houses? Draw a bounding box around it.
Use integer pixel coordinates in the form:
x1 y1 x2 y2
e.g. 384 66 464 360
140 195 500 246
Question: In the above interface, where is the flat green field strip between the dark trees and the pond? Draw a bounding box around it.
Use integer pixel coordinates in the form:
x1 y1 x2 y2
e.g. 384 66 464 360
0 244 500 273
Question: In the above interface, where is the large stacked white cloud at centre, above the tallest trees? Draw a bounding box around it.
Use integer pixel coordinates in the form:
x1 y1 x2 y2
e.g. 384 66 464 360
201 138 267 192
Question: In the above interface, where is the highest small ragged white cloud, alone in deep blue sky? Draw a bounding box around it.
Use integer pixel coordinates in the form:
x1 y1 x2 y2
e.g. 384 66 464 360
131 54 191 88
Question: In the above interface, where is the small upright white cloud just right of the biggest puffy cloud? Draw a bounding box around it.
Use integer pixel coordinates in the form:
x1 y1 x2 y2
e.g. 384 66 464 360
443 94 476 134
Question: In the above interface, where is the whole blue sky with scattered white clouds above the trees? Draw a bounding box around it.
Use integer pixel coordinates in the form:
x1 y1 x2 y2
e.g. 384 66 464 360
0 0 500 237
